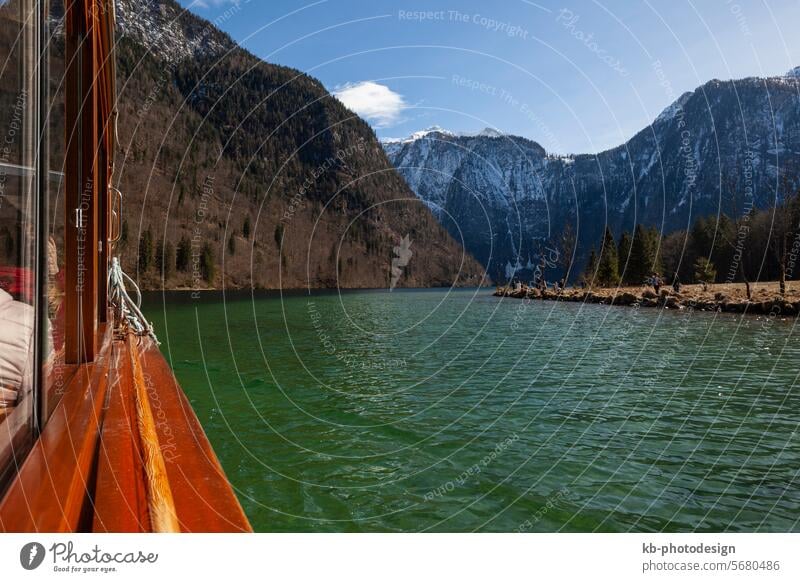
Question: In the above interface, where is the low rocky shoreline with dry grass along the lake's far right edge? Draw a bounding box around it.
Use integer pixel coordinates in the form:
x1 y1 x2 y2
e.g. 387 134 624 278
494 283 800 317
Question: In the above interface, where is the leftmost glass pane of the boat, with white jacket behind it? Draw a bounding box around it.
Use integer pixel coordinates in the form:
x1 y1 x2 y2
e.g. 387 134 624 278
0 0 39 485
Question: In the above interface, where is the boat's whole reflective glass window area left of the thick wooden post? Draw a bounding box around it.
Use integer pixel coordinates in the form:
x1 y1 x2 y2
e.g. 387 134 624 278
0 0 65 491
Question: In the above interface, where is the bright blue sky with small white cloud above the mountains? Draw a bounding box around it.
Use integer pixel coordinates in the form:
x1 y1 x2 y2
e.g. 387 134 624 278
180 0 800 153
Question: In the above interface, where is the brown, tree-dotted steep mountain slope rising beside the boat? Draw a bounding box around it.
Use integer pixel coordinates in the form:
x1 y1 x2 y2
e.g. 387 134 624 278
107 0 484 288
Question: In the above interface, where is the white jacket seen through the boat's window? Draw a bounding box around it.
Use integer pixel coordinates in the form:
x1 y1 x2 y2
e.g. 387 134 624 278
0 289 34 408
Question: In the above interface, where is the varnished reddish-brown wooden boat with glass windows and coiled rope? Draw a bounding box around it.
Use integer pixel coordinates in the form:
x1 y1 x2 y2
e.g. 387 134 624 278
0 0 252 533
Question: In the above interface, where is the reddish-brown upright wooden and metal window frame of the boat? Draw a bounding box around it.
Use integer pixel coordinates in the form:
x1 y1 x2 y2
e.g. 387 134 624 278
0 0 118 494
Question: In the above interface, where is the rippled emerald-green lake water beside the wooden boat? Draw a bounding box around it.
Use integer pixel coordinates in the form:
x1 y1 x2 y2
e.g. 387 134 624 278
145 289 800 532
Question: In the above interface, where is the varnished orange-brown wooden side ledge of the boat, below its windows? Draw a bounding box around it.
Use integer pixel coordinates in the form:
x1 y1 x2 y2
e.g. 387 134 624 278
0 327 252 532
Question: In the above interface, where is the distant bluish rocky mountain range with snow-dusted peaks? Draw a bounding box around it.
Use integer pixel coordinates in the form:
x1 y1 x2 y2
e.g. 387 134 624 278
384 72 800 280
